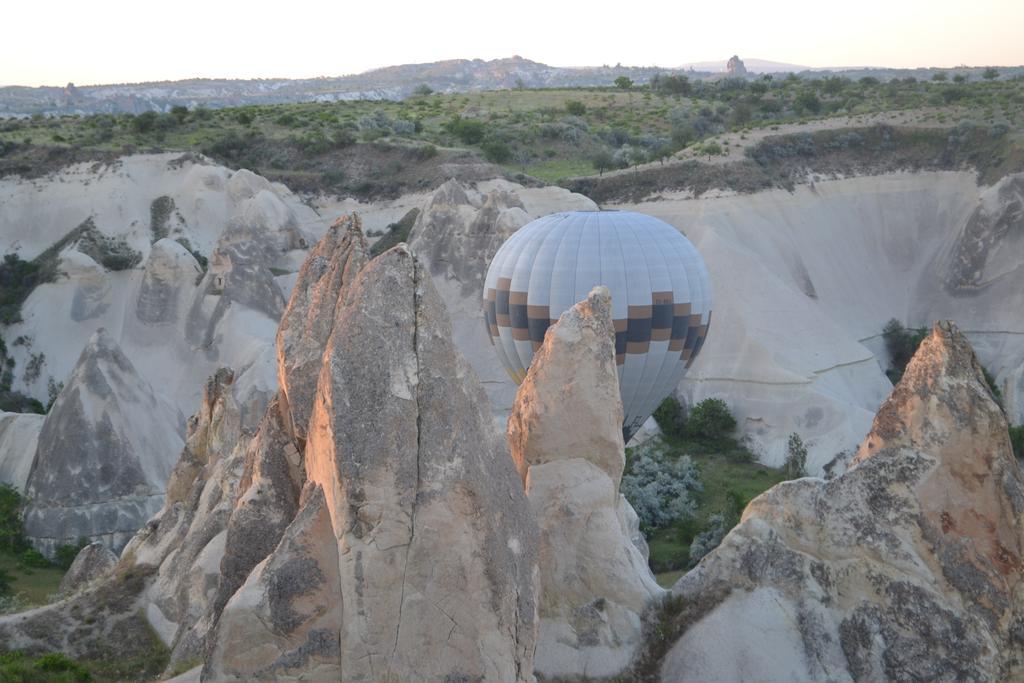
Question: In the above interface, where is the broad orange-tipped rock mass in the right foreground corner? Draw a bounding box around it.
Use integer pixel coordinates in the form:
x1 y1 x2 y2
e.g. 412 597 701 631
662 323 1024 681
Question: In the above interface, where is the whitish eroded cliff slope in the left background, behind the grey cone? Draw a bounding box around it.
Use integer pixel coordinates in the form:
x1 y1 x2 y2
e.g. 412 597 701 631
0 154 319 450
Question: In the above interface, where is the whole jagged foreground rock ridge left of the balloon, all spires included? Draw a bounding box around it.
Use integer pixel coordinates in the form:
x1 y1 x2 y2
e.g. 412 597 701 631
0 220 538 681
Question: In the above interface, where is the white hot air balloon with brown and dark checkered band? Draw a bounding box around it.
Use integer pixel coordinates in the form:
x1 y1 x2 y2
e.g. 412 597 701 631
483 211 711 441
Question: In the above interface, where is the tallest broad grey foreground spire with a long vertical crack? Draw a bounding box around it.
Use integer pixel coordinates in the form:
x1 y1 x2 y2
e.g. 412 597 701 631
292 246 537 681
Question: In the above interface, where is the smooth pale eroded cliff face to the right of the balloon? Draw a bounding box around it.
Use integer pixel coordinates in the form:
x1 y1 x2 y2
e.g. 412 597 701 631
608 171 1024 473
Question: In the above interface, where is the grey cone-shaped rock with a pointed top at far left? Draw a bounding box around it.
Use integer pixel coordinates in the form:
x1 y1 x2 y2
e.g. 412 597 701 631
25 330 183 554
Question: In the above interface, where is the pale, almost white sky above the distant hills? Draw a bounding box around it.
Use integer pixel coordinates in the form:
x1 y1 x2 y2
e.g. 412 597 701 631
0 0 1024 85
